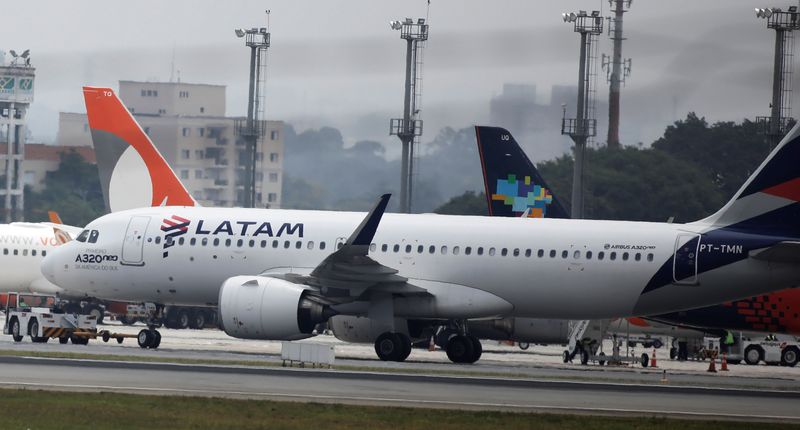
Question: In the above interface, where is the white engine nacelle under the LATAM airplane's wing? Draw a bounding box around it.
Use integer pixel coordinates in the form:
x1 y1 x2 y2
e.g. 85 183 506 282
219 276 333 340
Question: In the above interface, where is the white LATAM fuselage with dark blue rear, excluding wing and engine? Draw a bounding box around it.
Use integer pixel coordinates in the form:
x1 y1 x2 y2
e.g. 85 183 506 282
42 207 800 319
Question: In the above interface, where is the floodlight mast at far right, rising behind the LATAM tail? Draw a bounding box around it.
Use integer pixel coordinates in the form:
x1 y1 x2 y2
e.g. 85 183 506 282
755 6 800 147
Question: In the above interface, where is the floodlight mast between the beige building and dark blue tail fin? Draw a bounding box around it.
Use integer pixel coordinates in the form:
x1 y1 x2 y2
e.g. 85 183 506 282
389 18 428 213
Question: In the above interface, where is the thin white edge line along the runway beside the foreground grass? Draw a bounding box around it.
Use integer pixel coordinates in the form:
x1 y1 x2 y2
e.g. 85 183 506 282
0 381 800 421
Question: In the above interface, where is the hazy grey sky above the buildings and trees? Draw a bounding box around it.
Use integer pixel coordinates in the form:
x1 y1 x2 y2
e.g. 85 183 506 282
0 0 795 155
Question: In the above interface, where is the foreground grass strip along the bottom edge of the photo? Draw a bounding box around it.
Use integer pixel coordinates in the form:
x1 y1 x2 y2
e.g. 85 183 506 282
0 389 800 430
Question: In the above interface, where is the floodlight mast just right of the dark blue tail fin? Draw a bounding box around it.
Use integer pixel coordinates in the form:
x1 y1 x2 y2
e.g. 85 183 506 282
561 10 603 219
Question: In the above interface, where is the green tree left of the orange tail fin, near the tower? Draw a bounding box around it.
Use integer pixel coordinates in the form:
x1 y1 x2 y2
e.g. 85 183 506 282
25 150 105 226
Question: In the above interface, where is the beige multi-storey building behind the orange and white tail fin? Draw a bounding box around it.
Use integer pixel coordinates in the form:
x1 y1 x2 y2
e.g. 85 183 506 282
57 81 283 208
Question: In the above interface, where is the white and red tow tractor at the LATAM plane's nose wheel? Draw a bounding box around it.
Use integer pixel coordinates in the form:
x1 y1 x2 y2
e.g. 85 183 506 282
3 293 136 345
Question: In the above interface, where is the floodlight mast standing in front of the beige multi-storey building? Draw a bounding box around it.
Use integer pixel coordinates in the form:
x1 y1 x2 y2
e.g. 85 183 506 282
234 11 270 208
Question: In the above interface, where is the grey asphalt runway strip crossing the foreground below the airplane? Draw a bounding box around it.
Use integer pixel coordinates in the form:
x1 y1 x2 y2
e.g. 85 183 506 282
0 357 800 422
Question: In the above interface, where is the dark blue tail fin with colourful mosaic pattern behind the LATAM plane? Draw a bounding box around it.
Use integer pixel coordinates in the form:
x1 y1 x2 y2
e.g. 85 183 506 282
475 126 570 218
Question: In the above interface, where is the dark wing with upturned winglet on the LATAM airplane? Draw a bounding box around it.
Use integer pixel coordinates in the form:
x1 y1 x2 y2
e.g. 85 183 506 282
263 194 427 298
